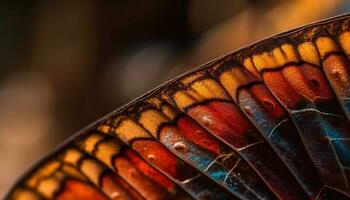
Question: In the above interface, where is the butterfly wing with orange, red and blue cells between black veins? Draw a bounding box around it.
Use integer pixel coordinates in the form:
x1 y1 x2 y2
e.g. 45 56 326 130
6 15 350 200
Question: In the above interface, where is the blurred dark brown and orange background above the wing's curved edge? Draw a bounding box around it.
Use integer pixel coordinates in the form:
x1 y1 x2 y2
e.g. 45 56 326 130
0 0 350 197
